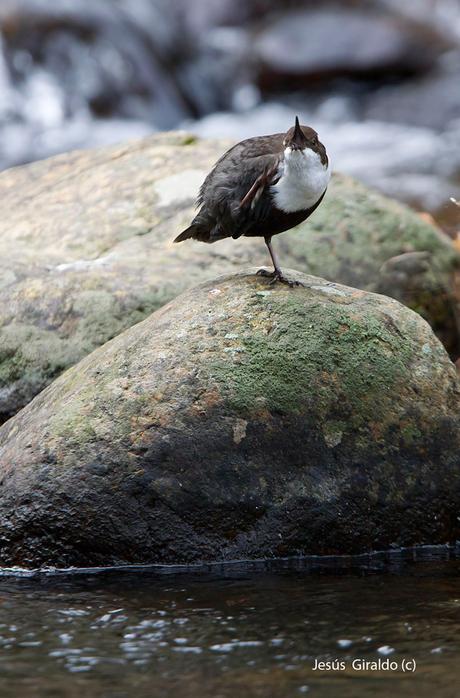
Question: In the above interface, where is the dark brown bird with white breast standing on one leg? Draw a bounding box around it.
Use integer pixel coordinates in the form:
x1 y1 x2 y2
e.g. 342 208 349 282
174 116 331 286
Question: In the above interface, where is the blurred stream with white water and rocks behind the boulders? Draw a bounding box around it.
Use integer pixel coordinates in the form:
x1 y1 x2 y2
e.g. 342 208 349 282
0 0 460 236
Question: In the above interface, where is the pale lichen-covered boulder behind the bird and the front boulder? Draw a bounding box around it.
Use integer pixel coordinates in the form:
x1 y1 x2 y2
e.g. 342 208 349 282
0 133 460 423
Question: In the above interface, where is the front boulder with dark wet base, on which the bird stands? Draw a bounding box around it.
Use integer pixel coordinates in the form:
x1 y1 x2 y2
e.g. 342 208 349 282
0 270 460 566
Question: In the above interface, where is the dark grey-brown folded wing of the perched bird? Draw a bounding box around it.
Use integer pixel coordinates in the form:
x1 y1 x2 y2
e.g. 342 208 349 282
195 134 284 241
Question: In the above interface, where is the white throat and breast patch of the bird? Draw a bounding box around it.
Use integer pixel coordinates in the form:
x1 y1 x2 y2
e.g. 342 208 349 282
271 148 331 213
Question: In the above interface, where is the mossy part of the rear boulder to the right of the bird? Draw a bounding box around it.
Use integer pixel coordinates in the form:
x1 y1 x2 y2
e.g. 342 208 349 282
280 171 460 350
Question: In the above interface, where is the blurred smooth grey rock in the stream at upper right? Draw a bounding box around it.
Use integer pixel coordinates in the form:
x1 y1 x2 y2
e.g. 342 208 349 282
254 4 447 91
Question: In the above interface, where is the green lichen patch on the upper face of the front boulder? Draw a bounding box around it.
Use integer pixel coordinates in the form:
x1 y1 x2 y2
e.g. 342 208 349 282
212 287 416 411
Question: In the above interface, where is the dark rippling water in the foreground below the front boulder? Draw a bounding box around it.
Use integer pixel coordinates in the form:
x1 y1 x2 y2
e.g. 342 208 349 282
0 548 460 698
